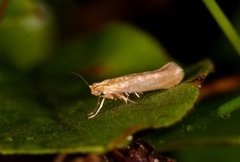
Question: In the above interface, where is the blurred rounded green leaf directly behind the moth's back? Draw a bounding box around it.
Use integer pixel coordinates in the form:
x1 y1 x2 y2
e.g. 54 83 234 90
42 23 172 78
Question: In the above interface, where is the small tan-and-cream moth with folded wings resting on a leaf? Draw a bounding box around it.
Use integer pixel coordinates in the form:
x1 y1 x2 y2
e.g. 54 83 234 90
85 62 184 118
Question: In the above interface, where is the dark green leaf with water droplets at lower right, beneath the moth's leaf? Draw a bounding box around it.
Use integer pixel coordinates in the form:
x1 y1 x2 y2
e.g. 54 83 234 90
145 87 240 151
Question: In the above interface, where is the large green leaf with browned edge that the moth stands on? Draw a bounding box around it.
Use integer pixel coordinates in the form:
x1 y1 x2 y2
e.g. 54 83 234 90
0 59 211 154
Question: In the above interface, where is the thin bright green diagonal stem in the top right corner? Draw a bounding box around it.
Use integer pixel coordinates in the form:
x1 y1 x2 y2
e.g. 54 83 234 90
203 0 240 56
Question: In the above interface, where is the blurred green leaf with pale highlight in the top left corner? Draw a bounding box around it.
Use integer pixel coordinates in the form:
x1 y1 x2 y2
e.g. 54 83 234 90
0 0 53 70
